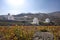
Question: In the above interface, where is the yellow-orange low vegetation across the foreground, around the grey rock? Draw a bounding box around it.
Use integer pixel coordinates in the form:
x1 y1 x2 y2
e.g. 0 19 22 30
0 25 60 40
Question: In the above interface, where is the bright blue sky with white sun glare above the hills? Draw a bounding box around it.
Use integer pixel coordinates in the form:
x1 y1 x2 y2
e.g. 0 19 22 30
0 0 60 15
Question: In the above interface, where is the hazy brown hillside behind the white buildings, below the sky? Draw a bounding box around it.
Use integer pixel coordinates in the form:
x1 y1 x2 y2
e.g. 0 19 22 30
0 11 60 25
